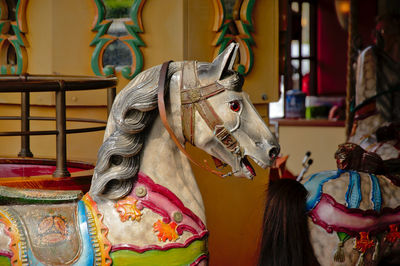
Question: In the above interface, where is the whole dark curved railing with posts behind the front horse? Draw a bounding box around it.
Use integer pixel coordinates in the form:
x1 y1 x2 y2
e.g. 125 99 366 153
0 74 117 177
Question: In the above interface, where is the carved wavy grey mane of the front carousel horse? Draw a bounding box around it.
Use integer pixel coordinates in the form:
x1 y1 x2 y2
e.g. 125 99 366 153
89 62 181 199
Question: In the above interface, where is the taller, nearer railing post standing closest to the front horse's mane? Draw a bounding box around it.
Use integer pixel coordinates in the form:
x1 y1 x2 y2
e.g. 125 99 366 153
53 80 71 177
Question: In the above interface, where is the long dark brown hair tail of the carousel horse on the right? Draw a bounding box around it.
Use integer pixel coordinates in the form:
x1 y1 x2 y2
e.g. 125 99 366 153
259 179 319 266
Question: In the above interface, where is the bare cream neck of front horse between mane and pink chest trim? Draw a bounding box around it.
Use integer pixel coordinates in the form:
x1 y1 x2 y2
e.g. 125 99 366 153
140 109 205 223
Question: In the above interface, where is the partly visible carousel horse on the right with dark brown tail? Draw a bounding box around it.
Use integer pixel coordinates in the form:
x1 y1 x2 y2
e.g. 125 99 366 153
259 23 400 266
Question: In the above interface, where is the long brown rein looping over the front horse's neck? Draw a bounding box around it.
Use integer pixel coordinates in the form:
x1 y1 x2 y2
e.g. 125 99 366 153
157 61 226 177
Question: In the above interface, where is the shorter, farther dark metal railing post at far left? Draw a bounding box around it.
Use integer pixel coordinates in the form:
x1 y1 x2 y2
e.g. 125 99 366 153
18 92 33 157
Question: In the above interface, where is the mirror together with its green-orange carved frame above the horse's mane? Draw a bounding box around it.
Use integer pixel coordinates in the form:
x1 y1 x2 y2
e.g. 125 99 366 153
90 0 145 79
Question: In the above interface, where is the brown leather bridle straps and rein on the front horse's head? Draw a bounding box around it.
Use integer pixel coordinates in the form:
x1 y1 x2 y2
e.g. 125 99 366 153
157 61 240 177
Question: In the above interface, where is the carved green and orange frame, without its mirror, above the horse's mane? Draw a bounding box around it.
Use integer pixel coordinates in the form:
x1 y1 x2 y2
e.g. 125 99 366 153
90 0 146 79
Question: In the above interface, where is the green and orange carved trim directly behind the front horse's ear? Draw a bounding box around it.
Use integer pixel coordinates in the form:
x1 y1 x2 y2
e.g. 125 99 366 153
212 0 256 75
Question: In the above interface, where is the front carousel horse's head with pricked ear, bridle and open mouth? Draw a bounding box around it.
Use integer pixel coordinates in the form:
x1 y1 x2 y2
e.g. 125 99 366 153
170 43 279 179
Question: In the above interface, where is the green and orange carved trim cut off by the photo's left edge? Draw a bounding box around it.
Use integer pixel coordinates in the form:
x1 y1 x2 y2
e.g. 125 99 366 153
0 0 28 75
